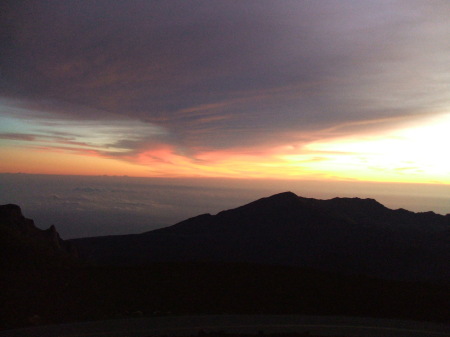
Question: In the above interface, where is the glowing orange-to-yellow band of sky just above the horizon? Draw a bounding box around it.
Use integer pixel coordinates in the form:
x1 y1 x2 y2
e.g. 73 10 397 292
0 114 450 184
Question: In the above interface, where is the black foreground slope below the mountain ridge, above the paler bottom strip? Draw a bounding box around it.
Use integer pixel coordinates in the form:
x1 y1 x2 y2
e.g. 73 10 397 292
0 263 450 329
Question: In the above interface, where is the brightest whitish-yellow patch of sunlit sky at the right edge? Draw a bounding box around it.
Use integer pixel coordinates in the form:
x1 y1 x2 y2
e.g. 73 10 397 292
298 114 450 183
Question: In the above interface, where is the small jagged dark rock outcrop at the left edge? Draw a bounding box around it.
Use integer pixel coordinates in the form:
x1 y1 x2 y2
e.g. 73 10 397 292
0 204 77 269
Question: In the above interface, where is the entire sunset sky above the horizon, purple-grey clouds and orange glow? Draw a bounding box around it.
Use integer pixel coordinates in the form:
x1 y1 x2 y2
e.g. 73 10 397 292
0 0 450 185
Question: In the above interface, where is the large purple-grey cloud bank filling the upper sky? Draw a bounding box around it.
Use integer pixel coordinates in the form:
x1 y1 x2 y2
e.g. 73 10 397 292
0 0 450 154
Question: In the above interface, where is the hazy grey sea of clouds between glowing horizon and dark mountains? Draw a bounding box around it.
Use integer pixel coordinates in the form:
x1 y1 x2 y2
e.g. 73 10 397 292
0 174 450 239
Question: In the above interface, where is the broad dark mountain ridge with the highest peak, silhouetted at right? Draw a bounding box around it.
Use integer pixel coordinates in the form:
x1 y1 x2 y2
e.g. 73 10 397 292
71 192 450 281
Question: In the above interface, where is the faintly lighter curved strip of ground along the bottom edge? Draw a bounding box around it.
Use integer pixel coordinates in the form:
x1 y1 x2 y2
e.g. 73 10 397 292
0 315 450 337
